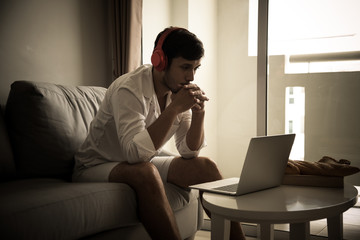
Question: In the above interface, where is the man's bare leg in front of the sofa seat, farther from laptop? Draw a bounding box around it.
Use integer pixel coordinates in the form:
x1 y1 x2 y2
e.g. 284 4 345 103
109 162 181 240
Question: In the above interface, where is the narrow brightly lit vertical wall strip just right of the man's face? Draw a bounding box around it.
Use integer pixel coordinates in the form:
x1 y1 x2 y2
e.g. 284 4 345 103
188 0 218 161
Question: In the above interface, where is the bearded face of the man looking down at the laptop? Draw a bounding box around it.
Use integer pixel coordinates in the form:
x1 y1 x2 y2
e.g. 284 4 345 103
163 57 201 93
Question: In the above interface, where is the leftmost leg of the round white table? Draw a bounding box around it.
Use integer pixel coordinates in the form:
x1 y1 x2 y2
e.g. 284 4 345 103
211 213 230 240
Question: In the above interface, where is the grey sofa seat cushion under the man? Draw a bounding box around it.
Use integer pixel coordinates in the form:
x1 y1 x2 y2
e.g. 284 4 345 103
0 178 197 240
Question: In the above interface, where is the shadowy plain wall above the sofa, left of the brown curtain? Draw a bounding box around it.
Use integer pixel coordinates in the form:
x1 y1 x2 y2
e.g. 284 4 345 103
0 0 111 105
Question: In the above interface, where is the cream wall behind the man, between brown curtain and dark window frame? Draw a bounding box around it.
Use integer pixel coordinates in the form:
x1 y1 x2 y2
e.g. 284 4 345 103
143 0 256 177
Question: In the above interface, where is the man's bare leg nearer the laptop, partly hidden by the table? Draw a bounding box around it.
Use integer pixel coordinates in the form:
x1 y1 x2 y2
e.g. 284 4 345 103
168 157 245 240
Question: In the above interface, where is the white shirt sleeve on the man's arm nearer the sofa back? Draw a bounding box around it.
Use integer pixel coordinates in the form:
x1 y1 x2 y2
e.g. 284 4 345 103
111 88 157 163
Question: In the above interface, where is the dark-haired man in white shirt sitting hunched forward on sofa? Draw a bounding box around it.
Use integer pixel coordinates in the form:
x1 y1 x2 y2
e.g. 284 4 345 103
73 28 245 239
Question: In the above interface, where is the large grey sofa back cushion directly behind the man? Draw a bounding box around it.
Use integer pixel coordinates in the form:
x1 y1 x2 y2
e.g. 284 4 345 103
5 81 106 178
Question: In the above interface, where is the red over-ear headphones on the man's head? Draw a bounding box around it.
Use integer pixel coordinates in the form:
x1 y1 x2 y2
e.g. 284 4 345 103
151 27 180 72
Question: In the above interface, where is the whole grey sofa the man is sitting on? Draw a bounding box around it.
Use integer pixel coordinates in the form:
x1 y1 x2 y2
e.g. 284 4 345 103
0 81 203 240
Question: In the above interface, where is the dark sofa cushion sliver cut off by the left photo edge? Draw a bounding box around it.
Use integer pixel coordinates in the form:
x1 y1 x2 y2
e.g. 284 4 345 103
0 109 15 181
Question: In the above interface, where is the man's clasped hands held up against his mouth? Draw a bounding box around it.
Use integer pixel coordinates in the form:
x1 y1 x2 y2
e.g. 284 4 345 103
172 84 209 113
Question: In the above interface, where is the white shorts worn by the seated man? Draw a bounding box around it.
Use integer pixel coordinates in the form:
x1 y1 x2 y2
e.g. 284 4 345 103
72 156 174 183
